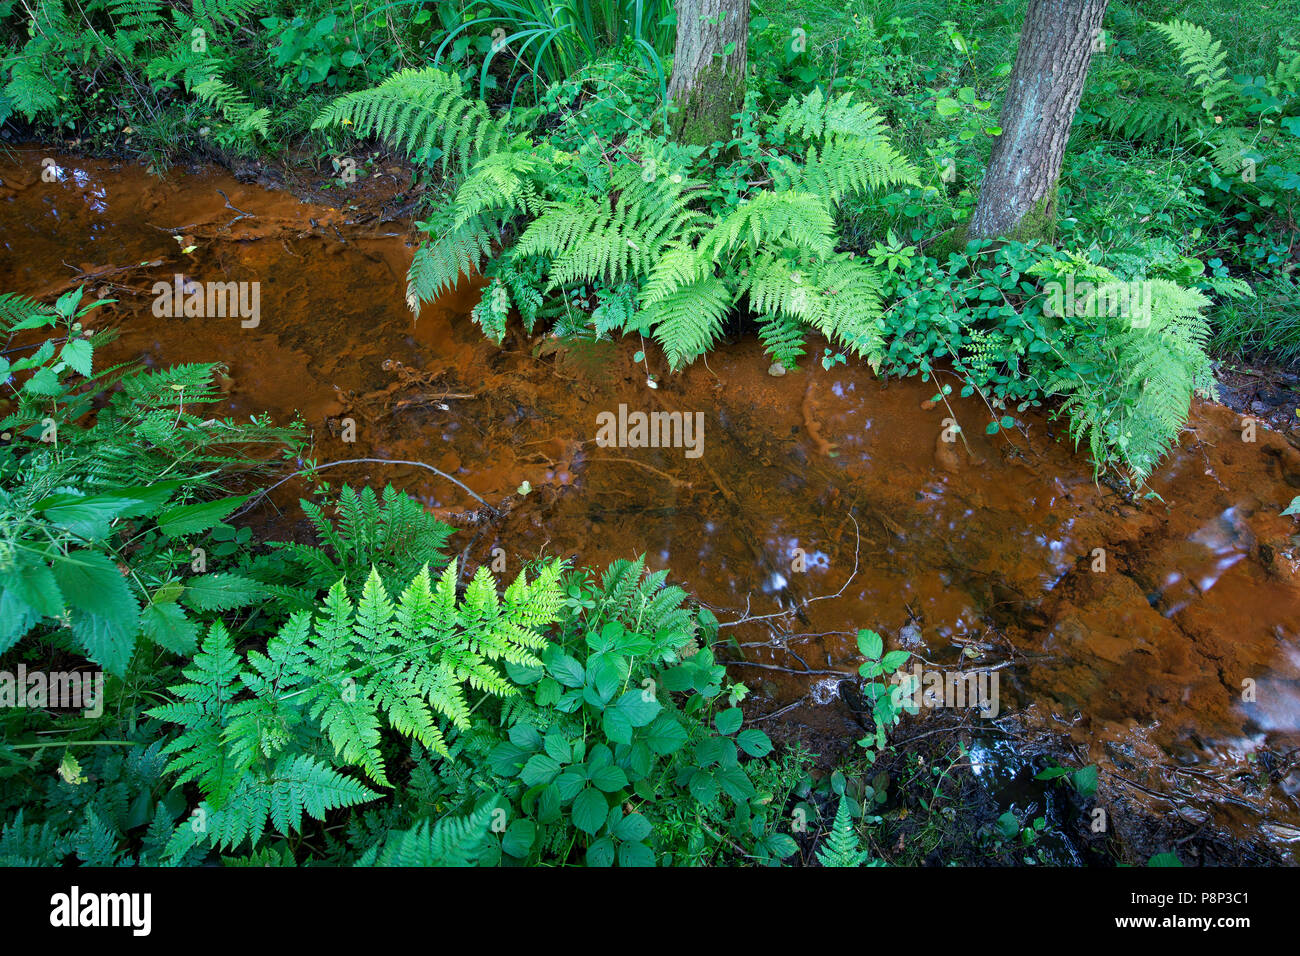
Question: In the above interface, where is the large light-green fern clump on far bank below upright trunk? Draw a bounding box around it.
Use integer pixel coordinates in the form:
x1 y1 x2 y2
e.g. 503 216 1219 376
316 70 915 368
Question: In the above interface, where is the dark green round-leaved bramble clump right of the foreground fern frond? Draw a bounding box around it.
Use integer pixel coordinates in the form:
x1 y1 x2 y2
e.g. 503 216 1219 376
447 559 796 866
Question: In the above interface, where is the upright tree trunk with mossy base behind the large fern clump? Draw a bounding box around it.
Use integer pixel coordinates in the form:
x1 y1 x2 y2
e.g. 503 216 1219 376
668 0 749 146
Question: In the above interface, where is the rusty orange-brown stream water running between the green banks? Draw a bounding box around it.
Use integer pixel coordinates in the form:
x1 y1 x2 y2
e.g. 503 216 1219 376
0 151 1300 858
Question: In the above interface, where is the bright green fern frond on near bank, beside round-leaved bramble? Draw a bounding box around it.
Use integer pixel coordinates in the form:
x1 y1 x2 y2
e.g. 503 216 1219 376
150 562 560 855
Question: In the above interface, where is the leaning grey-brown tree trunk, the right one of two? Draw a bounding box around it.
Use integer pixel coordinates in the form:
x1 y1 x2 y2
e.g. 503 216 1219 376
967 0 1106 239
